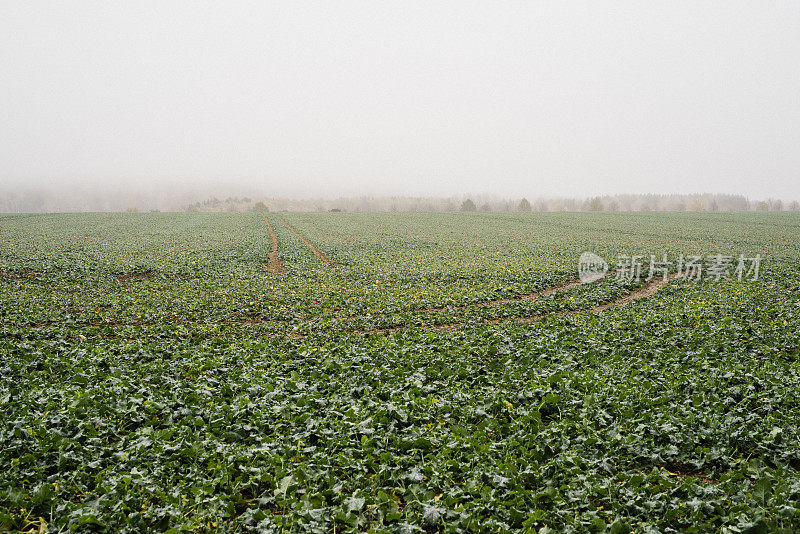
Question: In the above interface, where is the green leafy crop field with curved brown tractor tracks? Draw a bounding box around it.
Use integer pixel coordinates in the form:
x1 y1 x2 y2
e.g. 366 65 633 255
0 212 800 534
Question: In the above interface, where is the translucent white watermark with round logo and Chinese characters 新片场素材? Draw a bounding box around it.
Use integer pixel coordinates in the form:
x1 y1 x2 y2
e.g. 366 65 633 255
578 252 761 284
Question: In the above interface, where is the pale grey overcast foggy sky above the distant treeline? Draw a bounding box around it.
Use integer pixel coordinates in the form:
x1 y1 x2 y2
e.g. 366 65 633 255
0 0 800 199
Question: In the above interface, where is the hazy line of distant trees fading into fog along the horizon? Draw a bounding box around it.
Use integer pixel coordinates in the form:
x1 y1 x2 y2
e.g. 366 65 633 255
0 189 800 213
